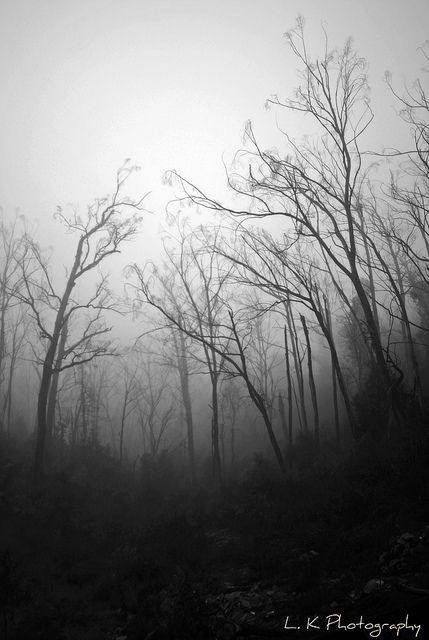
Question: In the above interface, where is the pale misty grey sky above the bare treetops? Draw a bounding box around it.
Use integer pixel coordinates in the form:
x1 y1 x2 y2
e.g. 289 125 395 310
0 0 429 258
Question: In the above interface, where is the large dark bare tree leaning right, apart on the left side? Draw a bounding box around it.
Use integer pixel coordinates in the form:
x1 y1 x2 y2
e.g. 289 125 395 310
19 165 143 482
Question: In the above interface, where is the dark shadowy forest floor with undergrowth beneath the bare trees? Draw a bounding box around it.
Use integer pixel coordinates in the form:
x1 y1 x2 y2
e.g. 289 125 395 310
0 432 429 640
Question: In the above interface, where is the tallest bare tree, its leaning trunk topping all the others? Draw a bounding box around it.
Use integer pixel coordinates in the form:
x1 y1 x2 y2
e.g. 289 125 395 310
166 18 395 418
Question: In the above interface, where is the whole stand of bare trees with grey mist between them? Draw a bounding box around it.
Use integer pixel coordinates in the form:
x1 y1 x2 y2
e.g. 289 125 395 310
0 20 429 483
